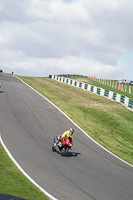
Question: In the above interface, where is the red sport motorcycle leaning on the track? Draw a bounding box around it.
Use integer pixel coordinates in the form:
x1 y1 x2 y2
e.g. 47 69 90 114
52 137 73 156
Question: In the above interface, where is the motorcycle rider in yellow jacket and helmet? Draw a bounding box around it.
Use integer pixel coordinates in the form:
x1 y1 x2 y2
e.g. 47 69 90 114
57 128 74 147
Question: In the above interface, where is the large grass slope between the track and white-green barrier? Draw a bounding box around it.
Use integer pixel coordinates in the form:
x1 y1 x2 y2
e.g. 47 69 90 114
17 77 133 164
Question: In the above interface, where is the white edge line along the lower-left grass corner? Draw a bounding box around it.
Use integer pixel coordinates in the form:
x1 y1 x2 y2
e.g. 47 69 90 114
0 135 57 200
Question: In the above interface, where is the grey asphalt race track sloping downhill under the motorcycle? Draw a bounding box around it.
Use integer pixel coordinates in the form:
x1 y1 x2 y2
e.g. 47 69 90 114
0 74 133 200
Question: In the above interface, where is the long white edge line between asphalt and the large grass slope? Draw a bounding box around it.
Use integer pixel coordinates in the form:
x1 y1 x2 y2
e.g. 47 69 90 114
15 76 133 167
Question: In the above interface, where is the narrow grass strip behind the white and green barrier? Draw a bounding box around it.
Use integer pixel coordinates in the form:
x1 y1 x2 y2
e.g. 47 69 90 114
69 77 133 99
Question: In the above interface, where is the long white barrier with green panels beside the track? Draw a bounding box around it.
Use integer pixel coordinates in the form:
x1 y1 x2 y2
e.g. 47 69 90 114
51 75 133 111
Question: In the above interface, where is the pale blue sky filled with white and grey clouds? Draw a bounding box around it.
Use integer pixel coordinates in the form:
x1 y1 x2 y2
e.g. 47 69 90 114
0 0 133 80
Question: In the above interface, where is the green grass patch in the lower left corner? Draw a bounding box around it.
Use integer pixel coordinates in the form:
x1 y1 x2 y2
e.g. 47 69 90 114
0 141 48 200
